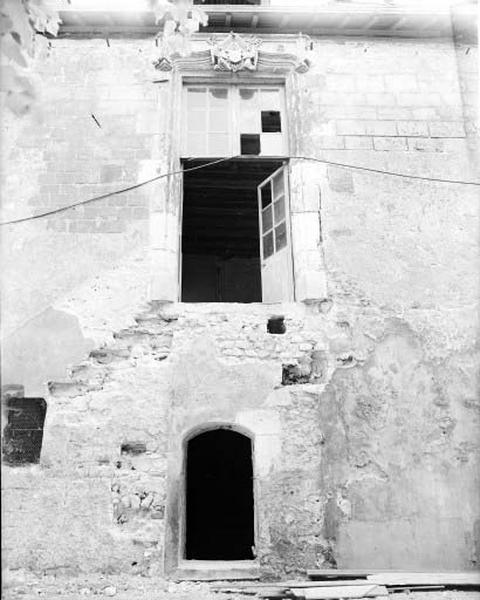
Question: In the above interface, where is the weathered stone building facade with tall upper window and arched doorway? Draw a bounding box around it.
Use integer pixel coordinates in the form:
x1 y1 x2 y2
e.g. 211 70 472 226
2 0 480 578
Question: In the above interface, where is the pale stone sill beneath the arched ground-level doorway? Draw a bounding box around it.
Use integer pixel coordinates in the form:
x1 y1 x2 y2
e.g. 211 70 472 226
173 560 260 581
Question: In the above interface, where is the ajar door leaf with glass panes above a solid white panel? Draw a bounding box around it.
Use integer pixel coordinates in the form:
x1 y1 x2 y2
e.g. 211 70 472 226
258 165 294 302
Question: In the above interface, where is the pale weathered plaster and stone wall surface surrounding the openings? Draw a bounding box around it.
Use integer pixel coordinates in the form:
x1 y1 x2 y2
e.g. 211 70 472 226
2 31 480 575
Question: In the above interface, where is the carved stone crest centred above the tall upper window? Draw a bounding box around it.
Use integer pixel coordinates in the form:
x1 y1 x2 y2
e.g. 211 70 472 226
209 31 262 73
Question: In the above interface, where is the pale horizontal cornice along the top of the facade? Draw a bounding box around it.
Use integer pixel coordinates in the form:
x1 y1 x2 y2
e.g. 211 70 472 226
55 1 478 38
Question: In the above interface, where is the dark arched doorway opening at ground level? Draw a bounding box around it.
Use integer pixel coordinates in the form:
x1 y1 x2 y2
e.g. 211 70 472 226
186 429 254 560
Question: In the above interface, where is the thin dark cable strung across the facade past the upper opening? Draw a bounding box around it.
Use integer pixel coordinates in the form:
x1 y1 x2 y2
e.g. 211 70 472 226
0 154 480 227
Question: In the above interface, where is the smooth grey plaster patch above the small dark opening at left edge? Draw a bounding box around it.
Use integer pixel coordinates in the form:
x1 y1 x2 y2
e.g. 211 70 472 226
2 308 93 396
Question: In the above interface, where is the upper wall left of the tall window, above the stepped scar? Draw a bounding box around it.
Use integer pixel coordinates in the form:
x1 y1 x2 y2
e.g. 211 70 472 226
2 38 166 395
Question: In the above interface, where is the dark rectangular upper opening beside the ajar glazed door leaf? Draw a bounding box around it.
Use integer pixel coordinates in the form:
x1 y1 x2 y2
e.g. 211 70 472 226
182 159 282 302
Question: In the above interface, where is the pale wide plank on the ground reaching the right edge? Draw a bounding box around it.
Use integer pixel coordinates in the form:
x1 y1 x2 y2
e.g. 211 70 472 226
367 571 480 587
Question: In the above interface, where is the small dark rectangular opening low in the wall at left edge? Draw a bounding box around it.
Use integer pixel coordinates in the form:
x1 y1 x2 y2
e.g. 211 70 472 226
2 398 47 466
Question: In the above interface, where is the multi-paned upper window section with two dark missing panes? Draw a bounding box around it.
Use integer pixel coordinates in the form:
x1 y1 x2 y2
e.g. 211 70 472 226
182 84 287 157
